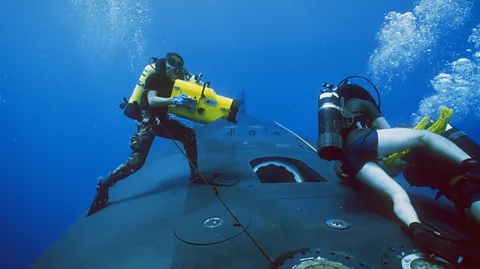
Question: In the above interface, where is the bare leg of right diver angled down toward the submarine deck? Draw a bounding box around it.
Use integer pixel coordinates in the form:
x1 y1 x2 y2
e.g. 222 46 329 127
356 162 420 227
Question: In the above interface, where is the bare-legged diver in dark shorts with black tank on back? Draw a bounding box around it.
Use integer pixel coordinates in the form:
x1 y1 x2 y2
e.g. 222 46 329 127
317 76 480 265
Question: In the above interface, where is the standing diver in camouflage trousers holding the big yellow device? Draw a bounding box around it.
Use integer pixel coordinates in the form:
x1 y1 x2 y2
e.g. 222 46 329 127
88 52 200 215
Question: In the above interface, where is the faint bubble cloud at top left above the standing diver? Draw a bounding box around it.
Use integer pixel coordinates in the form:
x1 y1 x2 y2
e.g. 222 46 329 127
71 0 151 69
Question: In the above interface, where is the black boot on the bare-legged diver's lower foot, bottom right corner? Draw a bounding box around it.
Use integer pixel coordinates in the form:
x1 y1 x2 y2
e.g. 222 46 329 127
409 222 480 268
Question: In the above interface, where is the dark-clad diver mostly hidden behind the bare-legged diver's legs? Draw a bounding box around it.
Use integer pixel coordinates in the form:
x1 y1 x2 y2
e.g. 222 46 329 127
335 108 480 225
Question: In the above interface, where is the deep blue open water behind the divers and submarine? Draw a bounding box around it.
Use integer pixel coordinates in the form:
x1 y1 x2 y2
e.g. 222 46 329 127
0 0 480 268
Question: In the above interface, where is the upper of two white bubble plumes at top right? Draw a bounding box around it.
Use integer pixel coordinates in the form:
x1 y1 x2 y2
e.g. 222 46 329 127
368 0 472 91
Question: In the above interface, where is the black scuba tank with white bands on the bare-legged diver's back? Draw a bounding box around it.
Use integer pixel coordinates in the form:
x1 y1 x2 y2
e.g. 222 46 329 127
317 83 345 161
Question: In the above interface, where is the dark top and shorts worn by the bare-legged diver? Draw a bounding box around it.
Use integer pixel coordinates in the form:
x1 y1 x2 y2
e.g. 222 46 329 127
342 98 382 176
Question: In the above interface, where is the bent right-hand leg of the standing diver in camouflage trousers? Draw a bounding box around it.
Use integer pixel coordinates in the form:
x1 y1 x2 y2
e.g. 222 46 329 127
155 118 198 180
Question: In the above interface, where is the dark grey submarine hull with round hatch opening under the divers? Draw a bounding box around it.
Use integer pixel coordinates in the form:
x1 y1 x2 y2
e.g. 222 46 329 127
29 116 480 269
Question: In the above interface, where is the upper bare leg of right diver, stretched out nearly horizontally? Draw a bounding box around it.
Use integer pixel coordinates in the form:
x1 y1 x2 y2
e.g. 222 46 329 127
377 128 471 164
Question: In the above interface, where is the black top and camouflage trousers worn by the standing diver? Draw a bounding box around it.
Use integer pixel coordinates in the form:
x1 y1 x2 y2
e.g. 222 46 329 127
105 58 197 186
